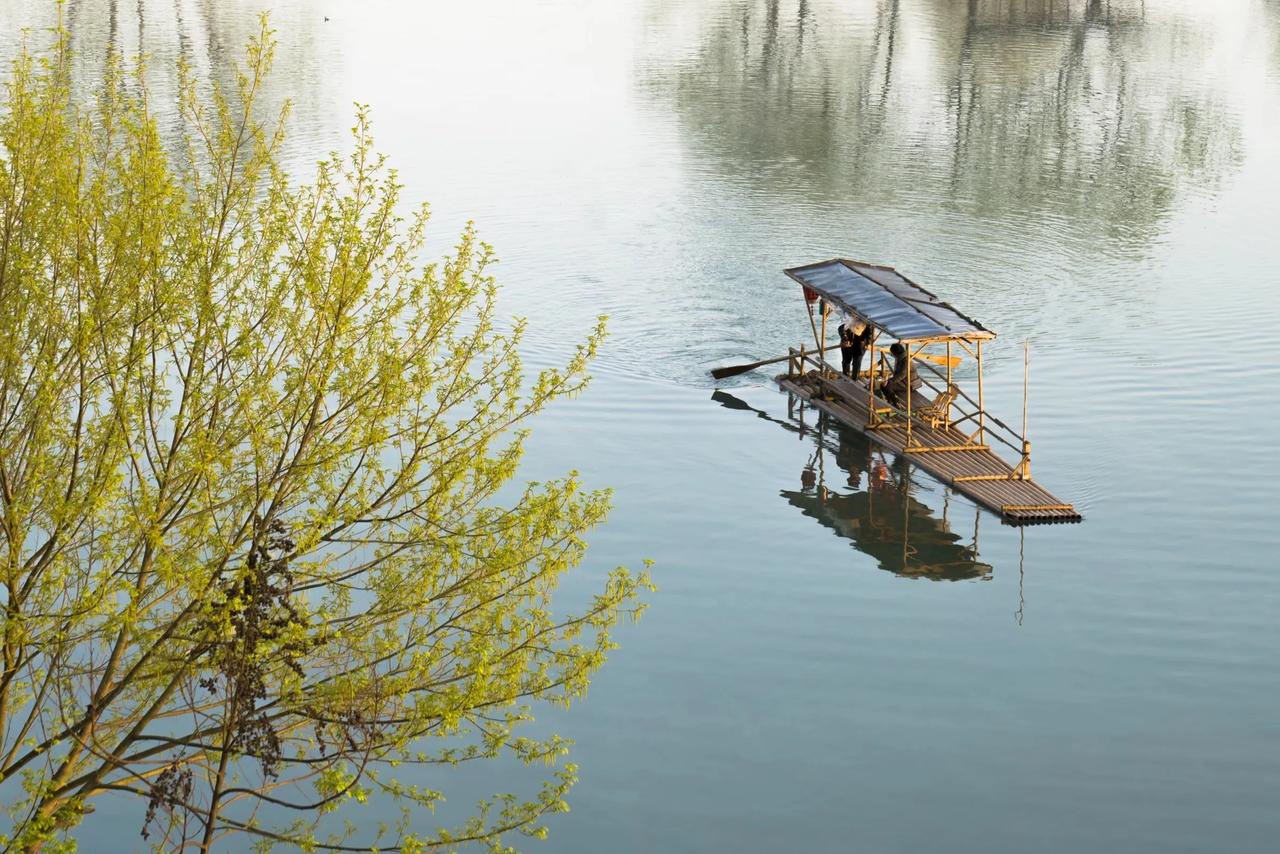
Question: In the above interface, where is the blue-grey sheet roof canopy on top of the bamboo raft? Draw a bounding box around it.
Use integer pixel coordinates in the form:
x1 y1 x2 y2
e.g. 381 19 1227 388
785 259 996 341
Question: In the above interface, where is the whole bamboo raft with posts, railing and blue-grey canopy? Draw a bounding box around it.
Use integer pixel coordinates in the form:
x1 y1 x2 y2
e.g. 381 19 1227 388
778 259 1080 525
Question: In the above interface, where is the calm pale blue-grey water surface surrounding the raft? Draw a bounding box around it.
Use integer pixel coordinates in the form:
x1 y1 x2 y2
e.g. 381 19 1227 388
0 0 1280 853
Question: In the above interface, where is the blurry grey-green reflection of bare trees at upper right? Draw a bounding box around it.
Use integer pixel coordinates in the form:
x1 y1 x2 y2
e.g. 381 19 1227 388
643 0 1239 250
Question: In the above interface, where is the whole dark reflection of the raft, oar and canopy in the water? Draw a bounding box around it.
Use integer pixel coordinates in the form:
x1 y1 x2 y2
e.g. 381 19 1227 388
712 391 992 581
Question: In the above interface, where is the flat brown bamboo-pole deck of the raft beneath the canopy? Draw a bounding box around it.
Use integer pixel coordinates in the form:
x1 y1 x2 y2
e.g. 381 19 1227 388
778 371 1082 525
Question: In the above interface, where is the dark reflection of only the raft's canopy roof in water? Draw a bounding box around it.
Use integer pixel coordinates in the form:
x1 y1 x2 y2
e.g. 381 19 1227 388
782 487 991 581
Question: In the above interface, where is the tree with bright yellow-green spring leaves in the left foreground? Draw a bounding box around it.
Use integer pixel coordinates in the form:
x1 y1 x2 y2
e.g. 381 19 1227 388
0 19 648 850
